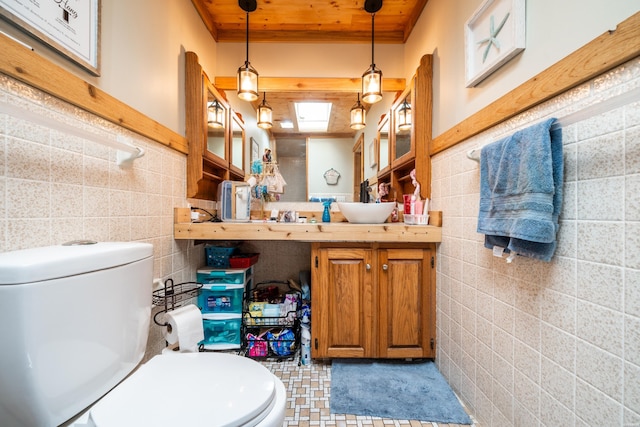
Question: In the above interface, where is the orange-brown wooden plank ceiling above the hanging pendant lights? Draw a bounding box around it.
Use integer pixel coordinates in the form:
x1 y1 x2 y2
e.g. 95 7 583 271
192 0 428 44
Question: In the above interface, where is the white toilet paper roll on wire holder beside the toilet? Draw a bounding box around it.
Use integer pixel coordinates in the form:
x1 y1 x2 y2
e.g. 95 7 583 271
162 304 204 352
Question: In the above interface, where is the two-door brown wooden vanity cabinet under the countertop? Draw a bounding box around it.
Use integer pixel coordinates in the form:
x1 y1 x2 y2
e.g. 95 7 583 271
311 243 436 358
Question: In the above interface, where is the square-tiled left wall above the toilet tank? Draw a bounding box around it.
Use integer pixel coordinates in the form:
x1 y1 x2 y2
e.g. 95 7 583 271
0 75 212 355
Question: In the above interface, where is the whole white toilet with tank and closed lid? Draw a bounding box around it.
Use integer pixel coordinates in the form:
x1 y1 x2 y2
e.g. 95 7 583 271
0 241 286 427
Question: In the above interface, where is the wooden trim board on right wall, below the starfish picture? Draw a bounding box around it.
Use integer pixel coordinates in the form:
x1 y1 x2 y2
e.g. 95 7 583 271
429 12 640 155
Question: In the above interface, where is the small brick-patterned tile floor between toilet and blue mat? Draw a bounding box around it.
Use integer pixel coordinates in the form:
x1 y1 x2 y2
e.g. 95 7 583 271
261 359 479 427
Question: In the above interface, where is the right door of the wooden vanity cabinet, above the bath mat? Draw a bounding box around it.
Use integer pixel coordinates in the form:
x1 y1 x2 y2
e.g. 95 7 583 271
378 249 435 358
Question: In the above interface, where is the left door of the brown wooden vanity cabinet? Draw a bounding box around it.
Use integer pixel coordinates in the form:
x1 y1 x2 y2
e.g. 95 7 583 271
311 248 375 358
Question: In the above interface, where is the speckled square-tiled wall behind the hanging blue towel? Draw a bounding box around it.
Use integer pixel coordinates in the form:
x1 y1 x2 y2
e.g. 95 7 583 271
432 60 640 426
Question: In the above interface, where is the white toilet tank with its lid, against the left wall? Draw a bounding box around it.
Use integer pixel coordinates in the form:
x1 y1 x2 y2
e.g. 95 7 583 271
0 242 153 427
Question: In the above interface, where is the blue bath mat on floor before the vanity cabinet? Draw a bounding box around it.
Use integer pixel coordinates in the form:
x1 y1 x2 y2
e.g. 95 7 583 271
330 359 471 424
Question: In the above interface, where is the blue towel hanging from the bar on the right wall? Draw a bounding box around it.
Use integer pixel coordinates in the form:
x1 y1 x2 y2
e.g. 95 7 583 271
478 119 564 262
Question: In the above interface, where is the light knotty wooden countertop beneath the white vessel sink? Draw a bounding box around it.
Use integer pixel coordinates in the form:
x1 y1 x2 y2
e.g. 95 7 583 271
173 208 442 243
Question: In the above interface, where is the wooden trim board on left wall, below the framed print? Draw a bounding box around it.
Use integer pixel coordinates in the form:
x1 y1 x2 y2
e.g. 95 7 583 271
0 34 188 154
